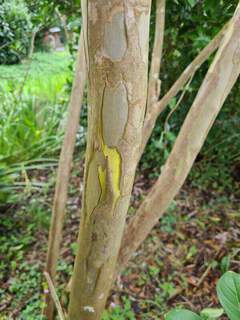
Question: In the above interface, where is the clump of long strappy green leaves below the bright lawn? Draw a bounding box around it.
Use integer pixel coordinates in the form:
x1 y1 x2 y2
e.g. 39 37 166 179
0 92 66 204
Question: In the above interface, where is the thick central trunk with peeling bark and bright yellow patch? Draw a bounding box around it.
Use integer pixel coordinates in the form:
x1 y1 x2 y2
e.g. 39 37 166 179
68 0 151 320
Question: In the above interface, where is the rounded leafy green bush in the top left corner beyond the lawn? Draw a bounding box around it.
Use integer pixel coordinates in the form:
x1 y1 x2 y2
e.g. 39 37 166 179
0 0 32 64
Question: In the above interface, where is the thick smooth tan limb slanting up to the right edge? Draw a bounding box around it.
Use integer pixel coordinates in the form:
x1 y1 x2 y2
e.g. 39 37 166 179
118 4 240 271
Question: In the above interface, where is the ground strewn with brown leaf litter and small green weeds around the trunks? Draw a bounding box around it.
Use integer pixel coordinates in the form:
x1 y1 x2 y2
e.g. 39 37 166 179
0 157 240 320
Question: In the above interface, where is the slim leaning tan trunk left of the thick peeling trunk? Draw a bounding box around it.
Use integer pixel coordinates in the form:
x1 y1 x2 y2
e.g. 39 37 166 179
44 34 86 320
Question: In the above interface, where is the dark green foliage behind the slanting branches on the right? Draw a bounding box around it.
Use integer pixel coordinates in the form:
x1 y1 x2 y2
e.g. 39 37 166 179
141 0 240 191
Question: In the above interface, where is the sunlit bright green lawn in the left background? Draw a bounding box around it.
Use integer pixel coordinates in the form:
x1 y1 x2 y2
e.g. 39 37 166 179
0 52 70 102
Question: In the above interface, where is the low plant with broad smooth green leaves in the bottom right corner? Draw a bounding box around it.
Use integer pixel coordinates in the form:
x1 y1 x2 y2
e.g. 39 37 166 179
165 271 240 320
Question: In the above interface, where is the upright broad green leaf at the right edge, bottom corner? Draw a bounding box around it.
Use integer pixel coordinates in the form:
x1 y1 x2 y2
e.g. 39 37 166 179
217 271 240 320
